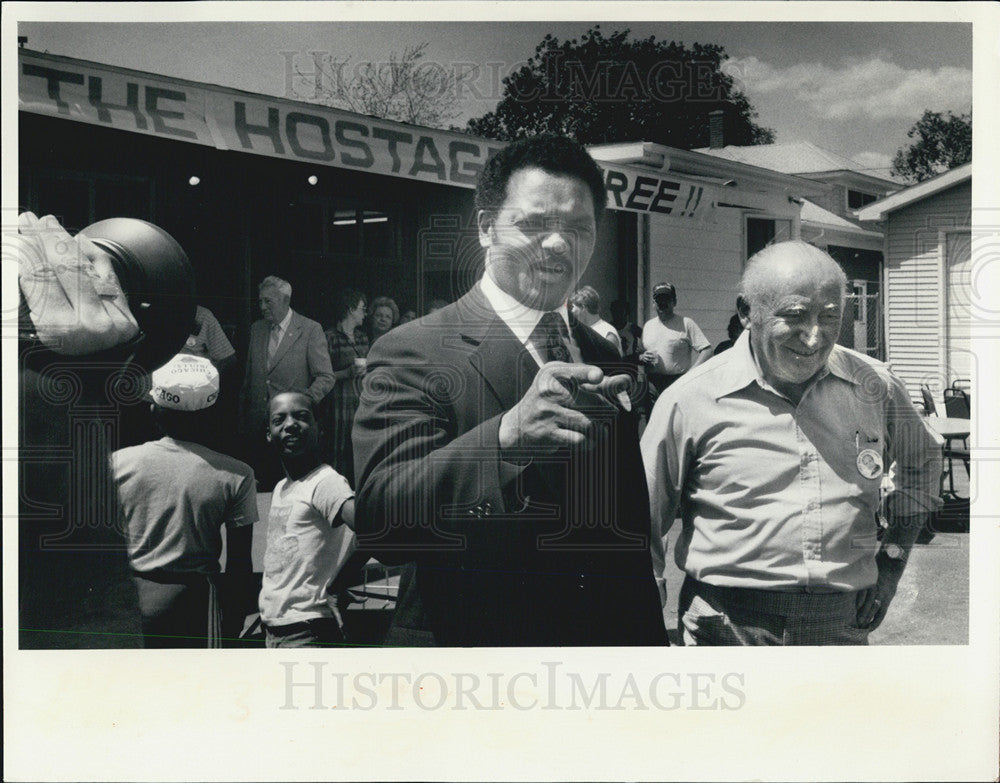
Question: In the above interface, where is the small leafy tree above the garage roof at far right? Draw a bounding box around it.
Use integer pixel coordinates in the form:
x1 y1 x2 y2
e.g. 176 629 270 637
892 110 972 183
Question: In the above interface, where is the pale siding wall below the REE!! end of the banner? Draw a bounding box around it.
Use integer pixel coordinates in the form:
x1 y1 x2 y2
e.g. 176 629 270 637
639 209 745 345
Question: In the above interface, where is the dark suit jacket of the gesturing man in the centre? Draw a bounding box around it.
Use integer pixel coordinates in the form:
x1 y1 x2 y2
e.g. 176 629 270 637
354 286 666 646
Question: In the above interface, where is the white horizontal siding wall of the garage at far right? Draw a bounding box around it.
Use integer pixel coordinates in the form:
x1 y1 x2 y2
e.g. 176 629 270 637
885 182 972 400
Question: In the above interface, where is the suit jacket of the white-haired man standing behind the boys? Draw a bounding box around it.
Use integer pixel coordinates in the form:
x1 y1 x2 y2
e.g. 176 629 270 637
240 310 334 438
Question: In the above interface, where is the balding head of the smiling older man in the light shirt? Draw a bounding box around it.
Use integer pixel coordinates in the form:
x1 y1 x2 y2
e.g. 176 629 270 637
737 242 847 402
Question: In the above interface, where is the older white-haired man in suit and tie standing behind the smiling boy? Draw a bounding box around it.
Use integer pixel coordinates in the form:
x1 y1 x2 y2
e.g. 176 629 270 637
240 275 334 490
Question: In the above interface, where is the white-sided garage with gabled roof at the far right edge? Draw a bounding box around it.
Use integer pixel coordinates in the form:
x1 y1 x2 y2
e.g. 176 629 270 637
855 163 977 403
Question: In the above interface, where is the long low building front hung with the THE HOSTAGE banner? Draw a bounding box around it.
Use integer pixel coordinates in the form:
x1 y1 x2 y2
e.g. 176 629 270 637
18 49 823 355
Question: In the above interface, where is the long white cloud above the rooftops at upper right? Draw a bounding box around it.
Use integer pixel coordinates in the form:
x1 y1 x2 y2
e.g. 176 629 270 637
724 57 972 121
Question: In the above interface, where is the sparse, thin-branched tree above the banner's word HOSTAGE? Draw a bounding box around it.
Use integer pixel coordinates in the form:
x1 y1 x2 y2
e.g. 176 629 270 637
298 41 460 128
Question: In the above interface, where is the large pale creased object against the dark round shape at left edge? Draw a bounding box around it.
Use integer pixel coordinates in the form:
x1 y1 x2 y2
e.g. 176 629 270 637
15 212 139 356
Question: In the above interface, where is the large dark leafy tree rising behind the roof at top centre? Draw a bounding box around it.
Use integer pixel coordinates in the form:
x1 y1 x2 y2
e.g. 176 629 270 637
468 26 774 149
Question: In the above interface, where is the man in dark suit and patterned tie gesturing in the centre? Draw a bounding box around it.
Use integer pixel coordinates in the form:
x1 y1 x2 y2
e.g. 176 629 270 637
354 135 666 646
